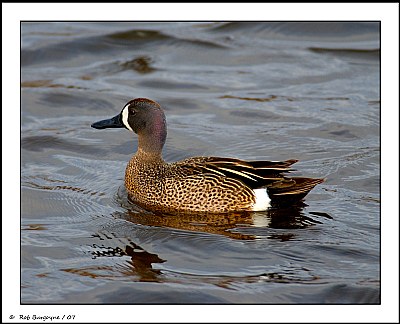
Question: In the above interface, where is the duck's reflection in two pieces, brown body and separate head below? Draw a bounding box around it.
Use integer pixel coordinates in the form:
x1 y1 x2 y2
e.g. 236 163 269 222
79 203 332 282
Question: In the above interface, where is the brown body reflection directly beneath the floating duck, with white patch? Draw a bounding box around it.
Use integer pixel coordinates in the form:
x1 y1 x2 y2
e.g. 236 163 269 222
114 202 332 240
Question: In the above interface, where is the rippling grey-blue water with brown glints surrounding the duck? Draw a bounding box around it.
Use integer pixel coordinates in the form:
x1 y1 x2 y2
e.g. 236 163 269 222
21 22 380 304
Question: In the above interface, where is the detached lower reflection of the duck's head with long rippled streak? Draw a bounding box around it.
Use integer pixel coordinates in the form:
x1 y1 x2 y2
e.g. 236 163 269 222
62 234 322 288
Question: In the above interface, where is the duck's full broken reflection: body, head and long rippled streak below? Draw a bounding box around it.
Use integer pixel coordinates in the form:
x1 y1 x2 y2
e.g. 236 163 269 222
63 188 332 289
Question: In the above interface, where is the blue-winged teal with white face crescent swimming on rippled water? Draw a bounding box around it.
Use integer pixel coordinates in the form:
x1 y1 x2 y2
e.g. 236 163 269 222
92 98 324 213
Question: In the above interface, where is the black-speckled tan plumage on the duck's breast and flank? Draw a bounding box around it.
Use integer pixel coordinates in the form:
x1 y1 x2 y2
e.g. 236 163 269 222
125 151 255 213
